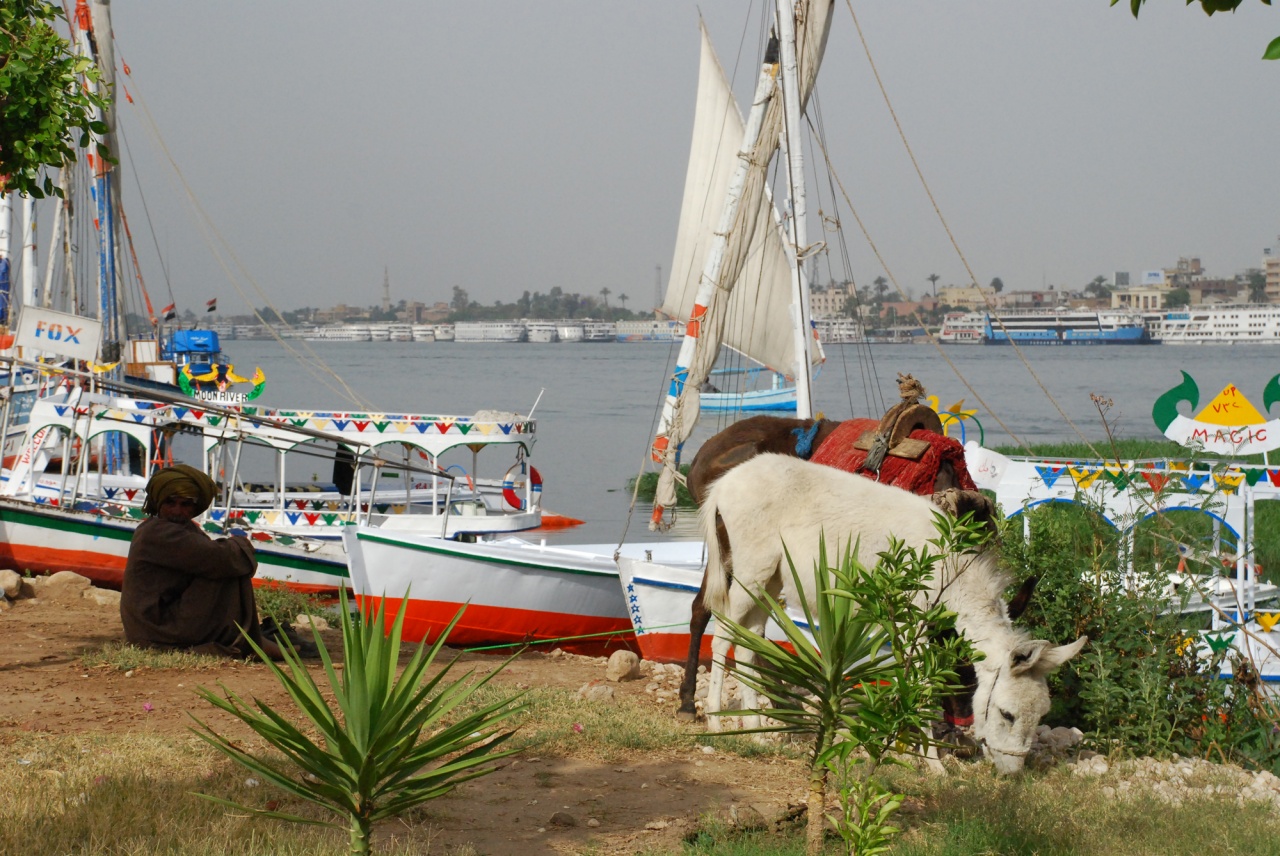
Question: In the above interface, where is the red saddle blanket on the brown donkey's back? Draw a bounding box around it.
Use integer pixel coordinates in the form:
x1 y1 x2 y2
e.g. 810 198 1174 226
809 420 978 496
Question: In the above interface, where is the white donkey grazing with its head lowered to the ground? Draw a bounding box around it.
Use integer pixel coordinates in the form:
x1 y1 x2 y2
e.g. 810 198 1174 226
699 454 1088 773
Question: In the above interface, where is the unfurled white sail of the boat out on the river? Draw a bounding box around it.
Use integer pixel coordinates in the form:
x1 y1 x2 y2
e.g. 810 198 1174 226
662 26 796 375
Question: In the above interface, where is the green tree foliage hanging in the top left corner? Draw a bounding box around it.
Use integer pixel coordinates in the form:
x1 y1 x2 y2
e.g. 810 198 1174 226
0 0 108 198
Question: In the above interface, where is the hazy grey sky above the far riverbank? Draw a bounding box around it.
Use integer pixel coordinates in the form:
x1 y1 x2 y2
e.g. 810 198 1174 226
102 0 1280 312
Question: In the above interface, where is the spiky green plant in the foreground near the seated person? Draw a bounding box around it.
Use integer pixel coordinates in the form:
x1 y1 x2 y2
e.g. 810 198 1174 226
192 592 527 853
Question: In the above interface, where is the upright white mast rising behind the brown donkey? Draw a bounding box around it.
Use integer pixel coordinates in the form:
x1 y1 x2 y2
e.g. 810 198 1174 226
777 0 813 418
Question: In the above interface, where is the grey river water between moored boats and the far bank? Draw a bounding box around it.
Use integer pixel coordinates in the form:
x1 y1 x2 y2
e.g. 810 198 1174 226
224 340 1280 543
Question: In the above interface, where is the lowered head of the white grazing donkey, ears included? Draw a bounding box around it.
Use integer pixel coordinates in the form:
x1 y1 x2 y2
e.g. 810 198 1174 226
973 636 1089 774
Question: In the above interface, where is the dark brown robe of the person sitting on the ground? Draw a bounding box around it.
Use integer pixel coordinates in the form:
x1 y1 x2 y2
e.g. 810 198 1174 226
120 517 262 656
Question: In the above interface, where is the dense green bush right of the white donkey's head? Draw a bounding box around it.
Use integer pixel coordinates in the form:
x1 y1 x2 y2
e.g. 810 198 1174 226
1004 493 1280 770
